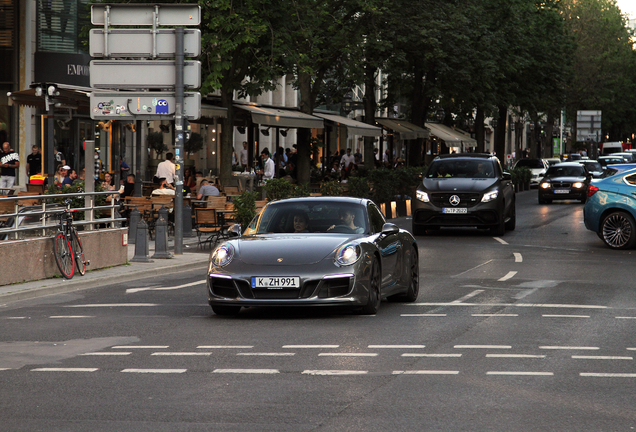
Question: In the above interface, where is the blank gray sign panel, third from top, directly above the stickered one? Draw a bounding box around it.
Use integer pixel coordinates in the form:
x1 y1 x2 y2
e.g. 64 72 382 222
90 60 201 90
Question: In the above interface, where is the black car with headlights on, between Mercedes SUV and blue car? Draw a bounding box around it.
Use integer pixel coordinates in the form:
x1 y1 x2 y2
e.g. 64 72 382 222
539 162 592 204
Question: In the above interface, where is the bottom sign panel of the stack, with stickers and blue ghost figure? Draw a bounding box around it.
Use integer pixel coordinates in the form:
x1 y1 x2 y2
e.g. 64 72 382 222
90 91 201 121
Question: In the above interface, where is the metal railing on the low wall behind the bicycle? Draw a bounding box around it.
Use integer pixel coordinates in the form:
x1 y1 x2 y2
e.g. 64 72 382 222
0 191 126 240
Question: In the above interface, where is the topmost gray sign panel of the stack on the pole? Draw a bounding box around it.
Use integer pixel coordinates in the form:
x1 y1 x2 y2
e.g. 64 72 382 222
91 3 201 26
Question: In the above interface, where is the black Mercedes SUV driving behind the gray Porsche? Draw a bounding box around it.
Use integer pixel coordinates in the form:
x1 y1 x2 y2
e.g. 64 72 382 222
411 153 516 236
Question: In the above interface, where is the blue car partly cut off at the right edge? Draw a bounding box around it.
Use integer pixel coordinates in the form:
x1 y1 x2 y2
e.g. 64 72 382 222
583 169 636 249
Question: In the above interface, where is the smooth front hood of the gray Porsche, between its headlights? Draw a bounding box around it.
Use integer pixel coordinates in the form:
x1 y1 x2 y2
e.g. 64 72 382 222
234 234 351 266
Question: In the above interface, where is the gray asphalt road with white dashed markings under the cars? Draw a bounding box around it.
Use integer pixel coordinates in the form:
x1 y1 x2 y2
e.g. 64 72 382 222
0 190 636 432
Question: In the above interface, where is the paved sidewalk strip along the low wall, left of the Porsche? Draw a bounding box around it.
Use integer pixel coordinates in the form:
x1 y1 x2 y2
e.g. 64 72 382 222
0 236 210 305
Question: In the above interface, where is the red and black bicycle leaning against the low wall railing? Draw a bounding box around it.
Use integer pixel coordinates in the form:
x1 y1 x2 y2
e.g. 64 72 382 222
53 200 90 279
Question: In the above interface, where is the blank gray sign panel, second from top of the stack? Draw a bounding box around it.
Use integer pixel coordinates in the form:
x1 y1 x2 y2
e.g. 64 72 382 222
89 29 201 58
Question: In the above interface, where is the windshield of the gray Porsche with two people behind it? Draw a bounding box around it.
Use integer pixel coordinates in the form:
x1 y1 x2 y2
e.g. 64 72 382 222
256 201 368 234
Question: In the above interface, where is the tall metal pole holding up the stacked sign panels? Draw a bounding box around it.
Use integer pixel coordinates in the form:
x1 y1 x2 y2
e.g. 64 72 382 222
174 27 185 255
